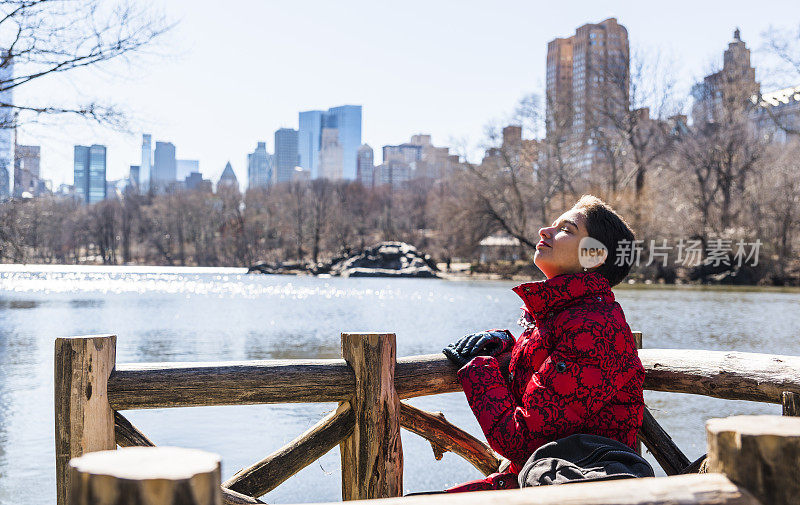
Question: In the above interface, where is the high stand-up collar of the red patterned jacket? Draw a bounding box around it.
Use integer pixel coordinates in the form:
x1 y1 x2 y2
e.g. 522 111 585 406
513 272 614 322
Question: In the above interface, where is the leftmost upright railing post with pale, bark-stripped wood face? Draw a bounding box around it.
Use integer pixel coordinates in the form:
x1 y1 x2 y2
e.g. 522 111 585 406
54 335 117 505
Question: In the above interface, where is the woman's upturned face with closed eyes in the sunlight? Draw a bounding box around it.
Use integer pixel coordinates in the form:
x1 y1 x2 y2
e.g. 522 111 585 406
533 209 589 279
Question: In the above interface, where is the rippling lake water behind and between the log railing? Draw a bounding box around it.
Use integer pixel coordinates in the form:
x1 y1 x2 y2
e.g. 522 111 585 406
0 265 800 505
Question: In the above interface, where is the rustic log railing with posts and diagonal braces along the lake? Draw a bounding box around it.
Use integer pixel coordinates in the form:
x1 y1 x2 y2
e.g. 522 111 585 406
55 332 800 505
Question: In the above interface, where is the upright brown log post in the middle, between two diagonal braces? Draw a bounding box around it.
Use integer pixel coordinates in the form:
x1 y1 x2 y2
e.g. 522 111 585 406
339 333 403 500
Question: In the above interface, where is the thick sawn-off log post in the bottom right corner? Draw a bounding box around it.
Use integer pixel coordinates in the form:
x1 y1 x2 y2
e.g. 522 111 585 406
706 416 800 505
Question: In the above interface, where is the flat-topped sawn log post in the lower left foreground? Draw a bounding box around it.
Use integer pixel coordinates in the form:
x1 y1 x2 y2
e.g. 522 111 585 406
69 447 222 505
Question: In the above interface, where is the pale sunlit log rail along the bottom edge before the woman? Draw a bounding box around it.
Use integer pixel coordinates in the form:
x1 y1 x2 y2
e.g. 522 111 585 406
298 474 756 505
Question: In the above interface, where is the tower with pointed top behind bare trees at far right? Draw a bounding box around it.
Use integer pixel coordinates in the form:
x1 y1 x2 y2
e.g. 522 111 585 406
692 28 761 124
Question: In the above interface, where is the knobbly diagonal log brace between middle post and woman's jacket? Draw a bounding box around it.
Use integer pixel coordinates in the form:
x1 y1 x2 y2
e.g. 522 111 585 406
400 402 503 475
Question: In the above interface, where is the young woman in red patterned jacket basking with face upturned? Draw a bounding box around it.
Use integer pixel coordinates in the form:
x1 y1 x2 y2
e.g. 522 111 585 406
443 195 644 492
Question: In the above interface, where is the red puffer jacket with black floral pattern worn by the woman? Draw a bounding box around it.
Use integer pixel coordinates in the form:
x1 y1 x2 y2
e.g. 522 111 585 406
448 272 644 492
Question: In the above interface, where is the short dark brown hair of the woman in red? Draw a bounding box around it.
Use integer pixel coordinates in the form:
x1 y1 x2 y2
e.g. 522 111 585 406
573 195 634 286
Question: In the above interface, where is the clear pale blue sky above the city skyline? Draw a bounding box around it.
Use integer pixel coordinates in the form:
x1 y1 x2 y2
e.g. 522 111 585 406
16 0 800 184
